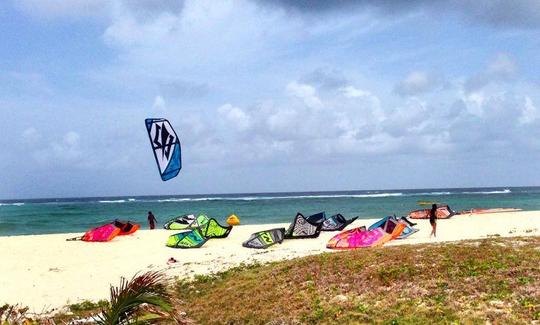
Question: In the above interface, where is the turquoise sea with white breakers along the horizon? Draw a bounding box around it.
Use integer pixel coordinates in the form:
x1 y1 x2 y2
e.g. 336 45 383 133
0 187 540 236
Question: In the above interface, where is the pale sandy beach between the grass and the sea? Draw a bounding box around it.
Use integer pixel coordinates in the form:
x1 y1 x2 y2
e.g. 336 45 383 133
0 211 540 312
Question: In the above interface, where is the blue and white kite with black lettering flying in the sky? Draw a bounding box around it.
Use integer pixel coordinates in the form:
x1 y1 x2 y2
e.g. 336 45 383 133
144 118 182 181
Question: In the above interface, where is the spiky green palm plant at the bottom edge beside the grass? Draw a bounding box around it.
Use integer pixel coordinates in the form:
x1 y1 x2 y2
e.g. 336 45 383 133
96 271 176 325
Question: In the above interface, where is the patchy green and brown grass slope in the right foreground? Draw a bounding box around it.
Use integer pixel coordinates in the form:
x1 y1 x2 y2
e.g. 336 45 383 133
176 237 540 324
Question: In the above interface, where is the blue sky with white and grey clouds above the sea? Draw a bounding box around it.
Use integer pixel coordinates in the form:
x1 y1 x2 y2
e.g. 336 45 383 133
0 0 540 199
